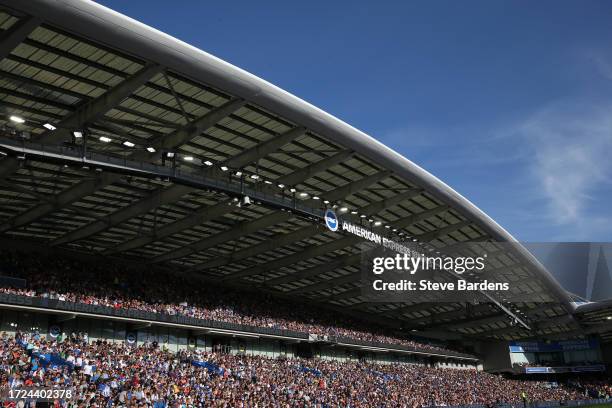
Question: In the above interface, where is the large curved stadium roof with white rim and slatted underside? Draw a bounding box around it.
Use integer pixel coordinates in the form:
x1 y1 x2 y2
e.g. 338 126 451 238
0 0 592 339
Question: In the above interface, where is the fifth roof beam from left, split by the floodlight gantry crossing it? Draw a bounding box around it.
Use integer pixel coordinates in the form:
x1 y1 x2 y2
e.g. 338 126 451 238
107 151 350 254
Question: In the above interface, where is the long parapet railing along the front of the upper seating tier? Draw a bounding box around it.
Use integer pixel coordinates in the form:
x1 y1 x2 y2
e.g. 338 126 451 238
0 293 477 360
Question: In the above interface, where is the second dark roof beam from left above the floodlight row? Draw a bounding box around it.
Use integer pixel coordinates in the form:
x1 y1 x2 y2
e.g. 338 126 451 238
39 64 163 143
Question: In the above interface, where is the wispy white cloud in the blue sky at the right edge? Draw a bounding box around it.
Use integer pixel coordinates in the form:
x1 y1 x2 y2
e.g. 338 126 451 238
515 103 612 231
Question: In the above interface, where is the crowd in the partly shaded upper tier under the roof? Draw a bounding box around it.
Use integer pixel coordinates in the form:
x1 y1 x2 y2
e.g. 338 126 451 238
0 251 454 351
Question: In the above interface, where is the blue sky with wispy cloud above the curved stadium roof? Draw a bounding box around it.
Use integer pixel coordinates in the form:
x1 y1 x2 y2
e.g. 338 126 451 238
100 0 612 242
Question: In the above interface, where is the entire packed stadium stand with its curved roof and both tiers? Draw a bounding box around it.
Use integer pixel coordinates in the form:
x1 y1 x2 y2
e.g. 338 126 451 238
0 0 612 408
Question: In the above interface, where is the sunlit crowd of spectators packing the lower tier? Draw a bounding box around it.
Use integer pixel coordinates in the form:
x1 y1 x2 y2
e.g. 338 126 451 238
0 332 612 408
